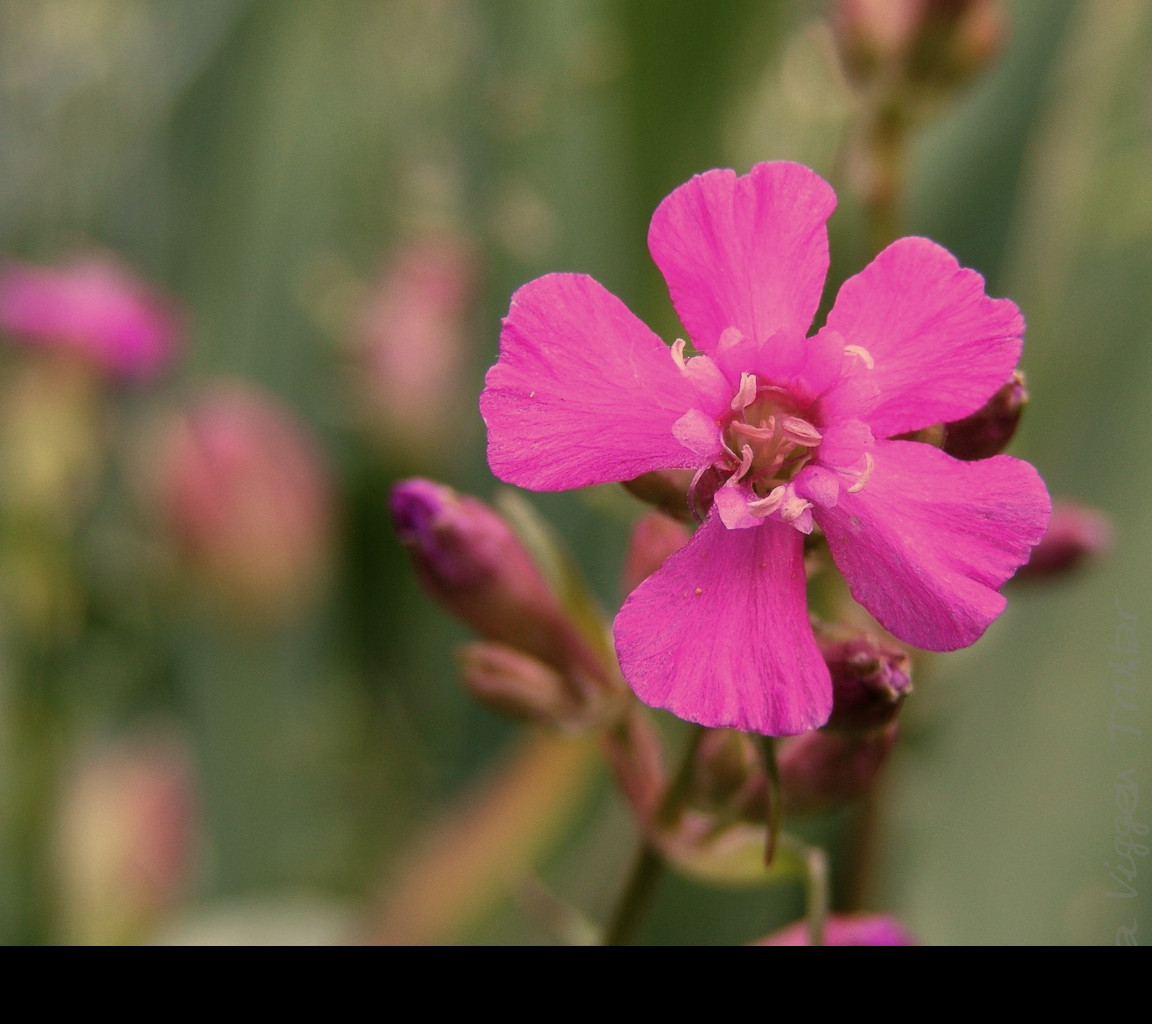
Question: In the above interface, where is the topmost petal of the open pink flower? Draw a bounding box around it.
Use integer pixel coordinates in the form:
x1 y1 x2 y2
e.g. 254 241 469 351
649 162 836 354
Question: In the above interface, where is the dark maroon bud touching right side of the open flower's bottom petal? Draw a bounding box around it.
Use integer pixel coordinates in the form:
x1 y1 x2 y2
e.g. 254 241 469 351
817 631 912 733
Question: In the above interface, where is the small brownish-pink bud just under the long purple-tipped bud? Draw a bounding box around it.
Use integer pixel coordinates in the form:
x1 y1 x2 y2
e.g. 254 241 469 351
458 643 581 725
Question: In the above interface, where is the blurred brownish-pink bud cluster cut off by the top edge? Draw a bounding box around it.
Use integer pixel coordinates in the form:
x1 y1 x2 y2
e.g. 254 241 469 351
832 0 1005 92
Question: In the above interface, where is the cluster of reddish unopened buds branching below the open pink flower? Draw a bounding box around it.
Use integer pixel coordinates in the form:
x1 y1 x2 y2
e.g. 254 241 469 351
392 479 911 881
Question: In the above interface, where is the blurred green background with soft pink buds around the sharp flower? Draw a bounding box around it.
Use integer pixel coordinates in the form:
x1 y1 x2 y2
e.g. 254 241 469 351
0 0 1152 945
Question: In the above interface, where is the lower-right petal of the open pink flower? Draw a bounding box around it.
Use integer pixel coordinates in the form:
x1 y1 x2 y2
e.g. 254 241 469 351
817 441 1051 651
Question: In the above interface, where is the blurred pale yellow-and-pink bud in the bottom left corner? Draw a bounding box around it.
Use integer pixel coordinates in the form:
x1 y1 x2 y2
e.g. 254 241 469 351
56 737 196 945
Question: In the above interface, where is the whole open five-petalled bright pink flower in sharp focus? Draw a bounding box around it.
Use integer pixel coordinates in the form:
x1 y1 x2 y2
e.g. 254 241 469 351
480 164 1049 735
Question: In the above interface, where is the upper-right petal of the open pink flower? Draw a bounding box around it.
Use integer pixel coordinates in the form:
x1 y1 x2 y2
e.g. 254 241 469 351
824 238 1024 438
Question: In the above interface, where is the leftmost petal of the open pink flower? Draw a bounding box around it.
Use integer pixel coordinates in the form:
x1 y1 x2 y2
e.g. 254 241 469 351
479 274 699 491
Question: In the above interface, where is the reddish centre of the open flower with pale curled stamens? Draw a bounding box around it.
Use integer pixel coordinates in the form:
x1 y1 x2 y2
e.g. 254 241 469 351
718 373 823 498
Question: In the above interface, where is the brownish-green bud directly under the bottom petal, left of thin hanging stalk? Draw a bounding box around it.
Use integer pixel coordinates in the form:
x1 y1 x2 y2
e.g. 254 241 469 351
689 729 767 824
